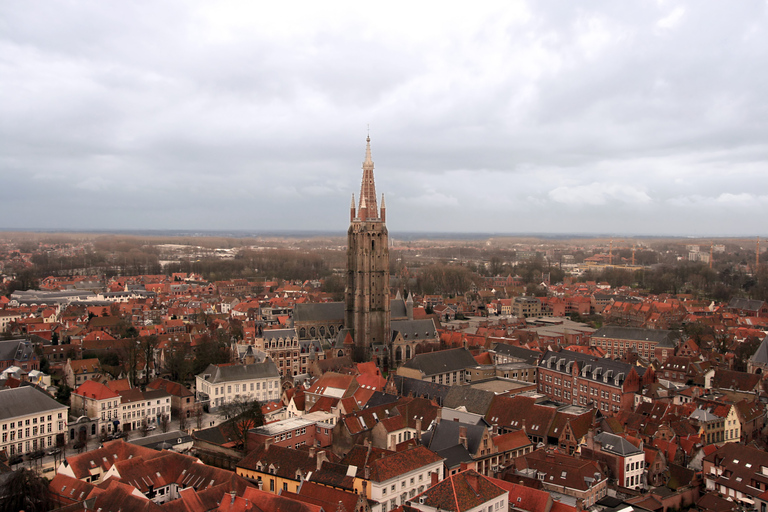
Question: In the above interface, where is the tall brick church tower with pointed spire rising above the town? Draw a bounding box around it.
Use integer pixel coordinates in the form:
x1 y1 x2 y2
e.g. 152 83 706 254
345 136 390 362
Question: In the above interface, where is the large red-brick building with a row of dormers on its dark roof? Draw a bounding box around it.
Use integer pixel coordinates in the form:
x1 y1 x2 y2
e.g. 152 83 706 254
538 350 655 415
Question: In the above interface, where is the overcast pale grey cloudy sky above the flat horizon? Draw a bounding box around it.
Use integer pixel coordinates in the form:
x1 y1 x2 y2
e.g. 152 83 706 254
0 0 768 236
